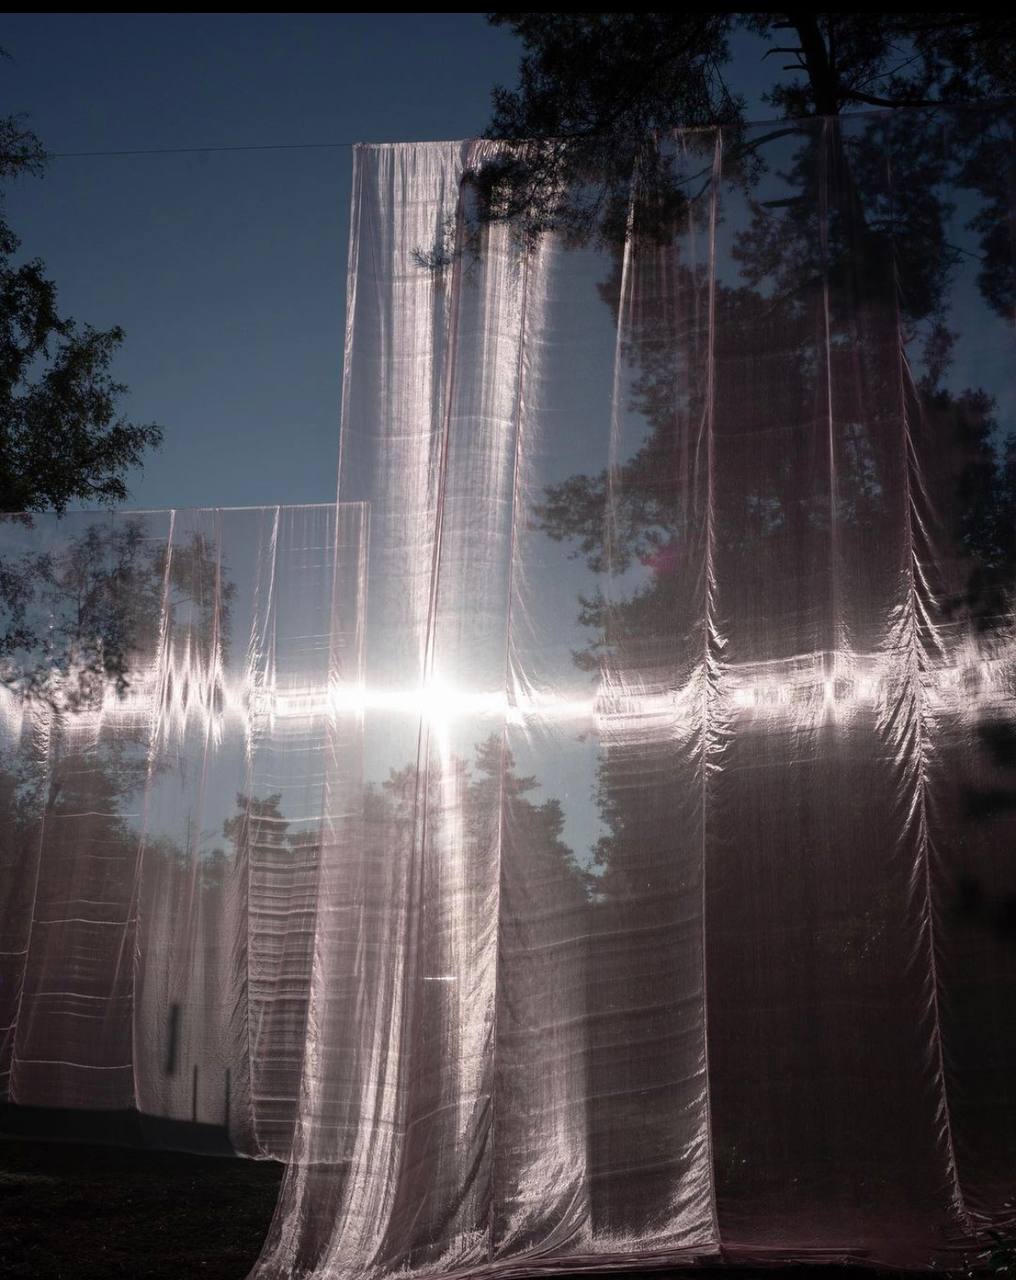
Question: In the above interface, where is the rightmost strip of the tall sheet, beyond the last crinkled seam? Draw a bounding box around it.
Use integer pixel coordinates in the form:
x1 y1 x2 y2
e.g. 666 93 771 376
883 108 1016 1230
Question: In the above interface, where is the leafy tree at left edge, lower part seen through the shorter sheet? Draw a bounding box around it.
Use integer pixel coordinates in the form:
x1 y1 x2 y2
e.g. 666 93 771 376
0 86 163 705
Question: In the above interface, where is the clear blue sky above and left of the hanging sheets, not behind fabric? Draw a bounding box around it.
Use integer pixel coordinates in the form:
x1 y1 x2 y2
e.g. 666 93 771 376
0 13 769 507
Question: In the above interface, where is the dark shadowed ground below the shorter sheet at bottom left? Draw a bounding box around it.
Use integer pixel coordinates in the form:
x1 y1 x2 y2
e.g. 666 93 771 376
0 1139 282 1280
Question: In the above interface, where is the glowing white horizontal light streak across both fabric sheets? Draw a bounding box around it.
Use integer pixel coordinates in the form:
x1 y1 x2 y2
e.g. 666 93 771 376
0 641 1016 741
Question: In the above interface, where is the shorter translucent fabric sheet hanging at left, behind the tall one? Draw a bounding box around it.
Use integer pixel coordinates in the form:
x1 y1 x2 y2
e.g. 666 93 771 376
0 506 366 1157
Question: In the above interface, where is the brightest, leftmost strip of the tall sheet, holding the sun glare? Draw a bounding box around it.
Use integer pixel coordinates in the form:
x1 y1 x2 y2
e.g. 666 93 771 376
261 137 521 1274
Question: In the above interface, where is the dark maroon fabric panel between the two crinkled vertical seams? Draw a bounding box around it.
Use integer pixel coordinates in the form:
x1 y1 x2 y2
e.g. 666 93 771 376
709 118 955 1262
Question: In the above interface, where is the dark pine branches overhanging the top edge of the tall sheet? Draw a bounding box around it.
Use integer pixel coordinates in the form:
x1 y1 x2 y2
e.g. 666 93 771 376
471 10 1016 243
